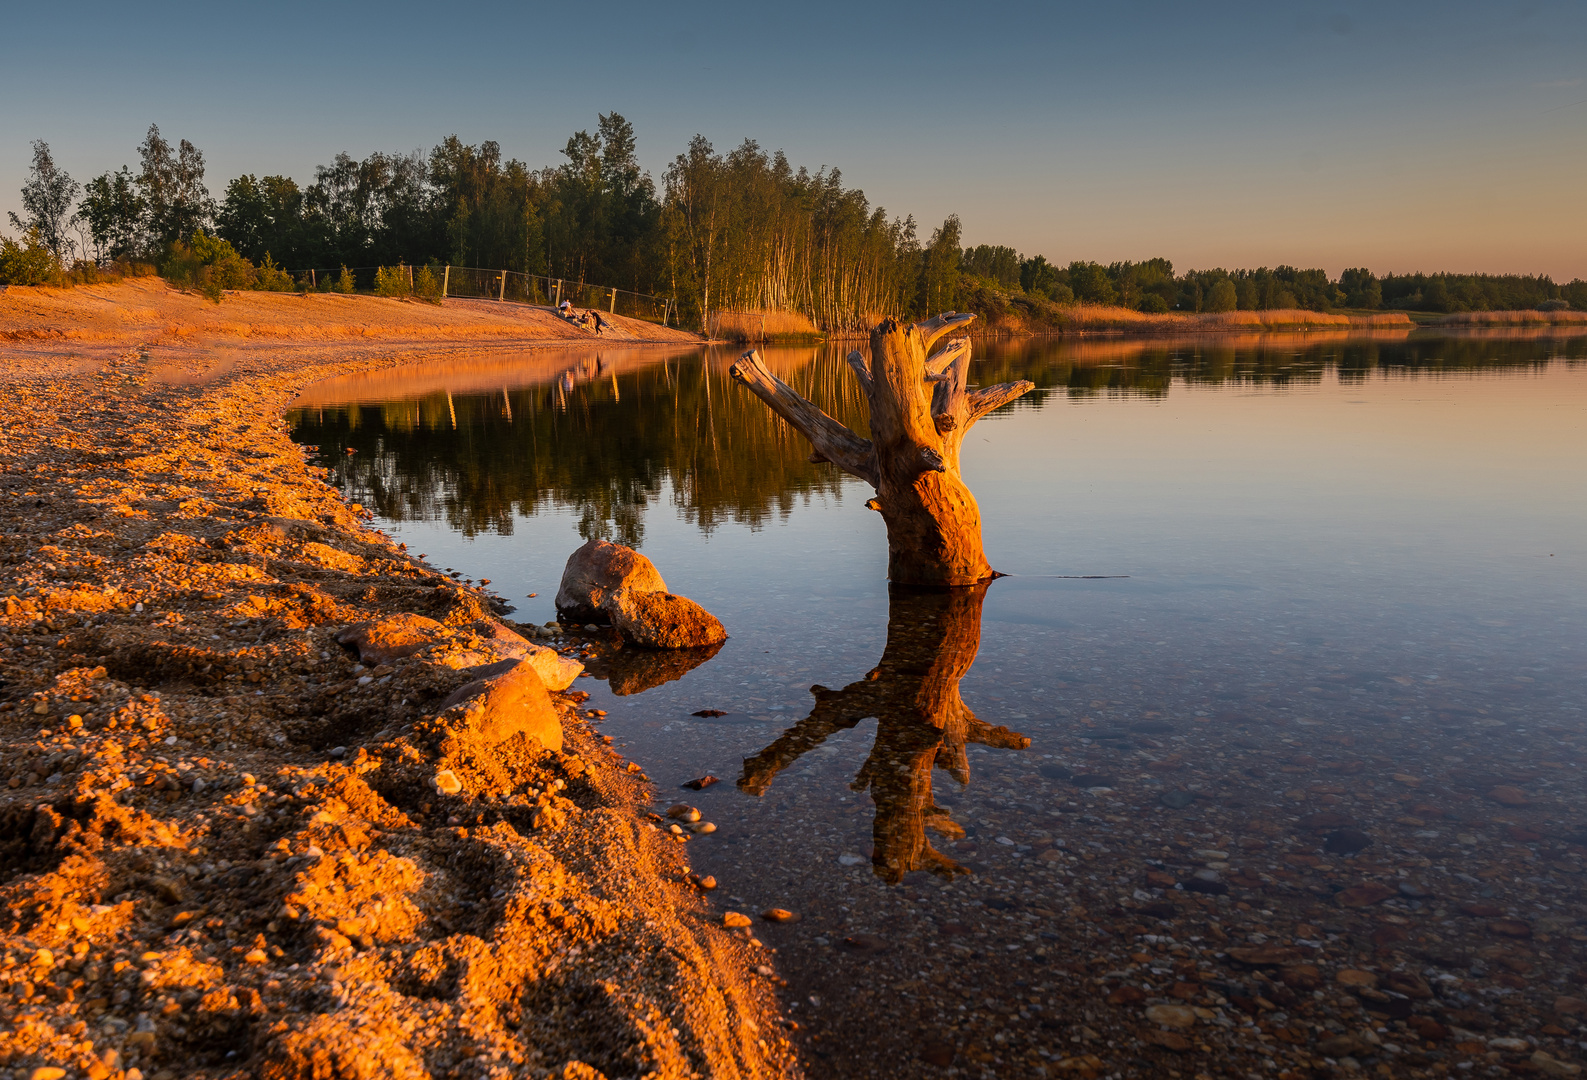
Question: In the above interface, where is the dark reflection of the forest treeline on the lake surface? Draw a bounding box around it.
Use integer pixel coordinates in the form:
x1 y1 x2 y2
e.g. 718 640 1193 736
289 330 1587 546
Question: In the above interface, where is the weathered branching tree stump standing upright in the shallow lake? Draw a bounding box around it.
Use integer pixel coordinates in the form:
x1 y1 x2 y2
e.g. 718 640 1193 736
732 312 1036 585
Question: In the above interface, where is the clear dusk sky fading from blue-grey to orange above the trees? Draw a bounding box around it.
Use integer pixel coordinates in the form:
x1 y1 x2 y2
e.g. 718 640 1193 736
0 0 1587 281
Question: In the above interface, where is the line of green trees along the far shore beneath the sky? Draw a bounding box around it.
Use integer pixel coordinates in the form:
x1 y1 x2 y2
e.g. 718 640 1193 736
0 113 1587 330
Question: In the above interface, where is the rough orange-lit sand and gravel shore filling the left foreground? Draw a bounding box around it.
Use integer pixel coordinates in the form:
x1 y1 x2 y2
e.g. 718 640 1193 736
0 283 795 1080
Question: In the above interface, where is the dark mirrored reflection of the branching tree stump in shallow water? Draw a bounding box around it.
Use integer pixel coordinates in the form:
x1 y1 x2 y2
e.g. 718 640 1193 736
738 582 1030 883
